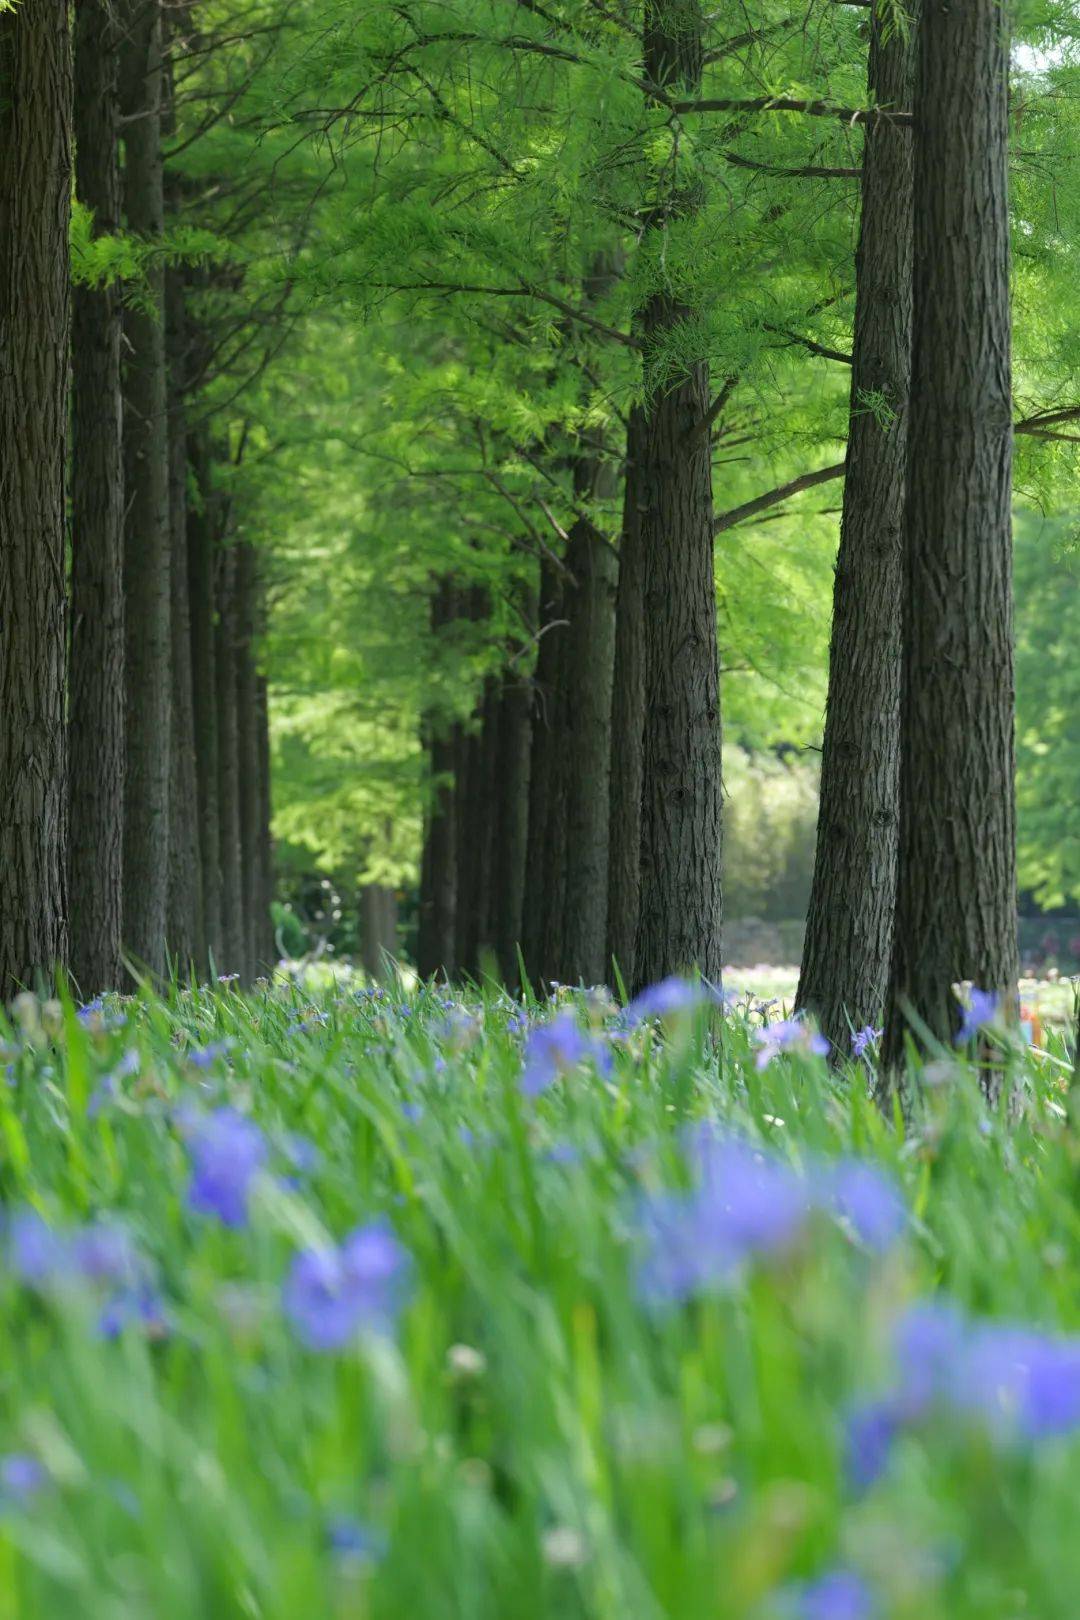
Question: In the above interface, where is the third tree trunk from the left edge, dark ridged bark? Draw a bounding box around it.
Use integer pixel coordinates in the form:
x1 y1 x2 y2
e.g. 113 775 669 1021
120 0 172 974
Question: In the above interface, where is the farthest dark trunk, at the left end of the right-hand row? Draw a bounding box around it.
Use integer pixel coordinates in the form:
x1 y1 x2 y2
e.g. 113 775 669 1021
416 580 458 978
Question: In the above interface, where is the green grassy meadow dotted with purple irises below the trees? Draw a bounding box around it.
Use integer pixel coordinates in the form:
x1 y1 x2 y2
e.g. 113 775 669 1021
0 975 1080 1620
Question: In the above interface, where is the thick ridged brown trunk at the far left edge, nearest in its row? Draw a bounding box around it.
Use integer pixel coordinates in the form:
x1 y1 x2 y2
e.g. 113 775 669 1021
0 0 73 1000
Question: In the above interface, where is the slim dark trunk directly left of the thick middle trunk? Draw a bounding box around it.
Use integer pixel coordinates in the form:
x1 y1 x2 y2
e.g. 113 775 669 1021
606 405 644 983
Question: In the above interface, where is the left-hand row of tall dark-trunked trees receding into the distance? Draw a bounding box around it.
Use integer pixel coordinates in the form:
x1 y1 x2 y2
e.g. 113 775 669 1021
0 0 272 996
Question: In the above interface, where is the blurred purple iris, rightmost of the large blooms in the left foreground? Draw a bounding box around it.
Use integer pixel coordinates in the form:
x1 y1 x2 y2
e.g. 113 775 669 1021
283 1220 410 1349
